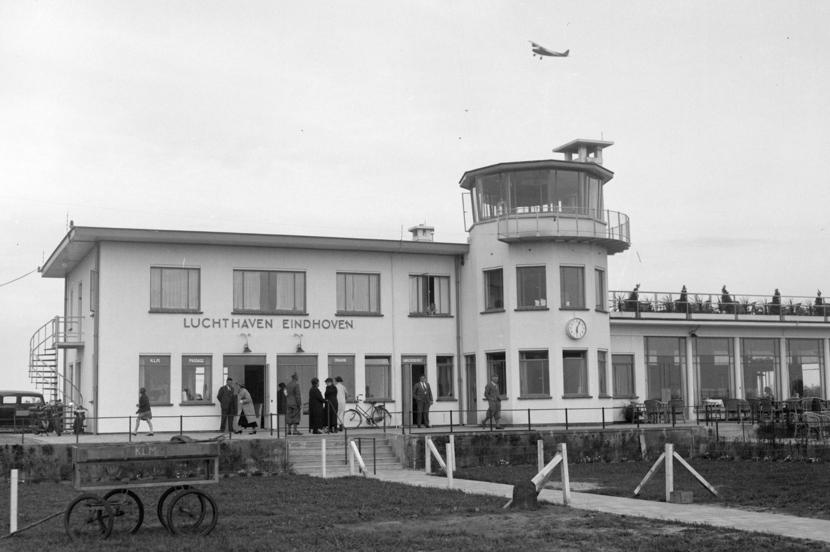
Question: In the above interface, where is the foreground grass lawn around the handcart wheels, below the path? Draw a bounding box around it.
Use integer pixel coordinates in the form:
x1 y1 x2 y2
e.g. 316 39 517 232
0 472 830 552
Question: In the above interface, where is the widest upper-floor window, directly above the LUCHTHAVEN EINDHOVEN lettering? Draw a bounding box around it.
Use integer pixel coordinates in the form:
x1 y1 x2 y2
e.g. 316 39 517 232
233 270 305 314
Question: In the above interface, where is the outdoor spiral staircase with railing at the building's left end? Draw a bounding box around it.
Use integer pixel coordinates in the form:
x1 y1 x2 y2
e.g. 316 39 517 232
29 316 84 405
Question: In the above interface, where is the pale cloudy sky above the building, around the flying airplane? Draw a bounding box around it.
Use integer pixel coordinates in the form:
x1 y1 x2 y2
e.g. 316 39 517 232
0 0 830 389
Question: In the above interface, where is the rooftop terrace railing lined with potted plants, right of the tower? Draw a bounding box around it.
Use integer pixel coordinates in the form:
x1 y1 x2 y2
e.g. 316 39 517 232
608 291 830 322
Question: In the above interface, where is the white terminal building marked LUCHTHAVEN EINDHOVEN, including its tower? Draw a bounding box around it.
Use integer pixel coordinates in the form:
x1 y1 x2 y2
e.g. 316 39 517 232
29 140 830 433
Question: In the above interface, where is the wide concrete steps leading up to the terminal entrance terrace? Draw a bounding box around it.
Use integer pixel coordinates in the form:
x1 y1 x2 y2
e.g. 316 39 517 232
288 433 402 476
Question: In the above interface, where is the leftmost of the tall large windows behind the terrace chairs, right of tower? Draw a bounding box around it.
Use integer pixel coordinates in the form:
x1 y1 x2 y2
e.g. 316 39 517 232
646 337 686 402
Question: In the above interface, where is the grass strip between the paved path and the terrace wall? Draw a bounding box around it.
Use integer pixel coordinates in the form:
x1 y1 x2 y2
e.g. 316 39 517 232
456 459 830 519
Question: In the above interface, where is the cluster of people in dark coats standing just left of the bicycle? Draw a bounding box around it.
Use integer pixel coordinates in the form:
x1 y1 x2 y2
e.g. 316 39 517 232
277 373 348 435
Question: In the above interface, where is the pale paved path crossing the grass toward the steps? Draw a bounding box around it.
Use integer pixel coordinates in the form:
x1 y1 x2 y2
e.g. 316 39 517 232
373 470 830 543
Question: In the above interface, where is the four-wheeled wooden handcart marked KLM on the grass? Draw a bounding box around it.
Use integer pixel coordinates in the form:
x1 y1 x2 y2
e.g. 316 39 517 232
64 442 219 540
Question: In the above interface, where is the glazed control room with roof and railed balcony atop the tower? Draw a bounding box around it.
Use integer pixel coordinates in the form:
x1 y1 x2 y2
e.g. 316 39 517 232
460 140 631 255
